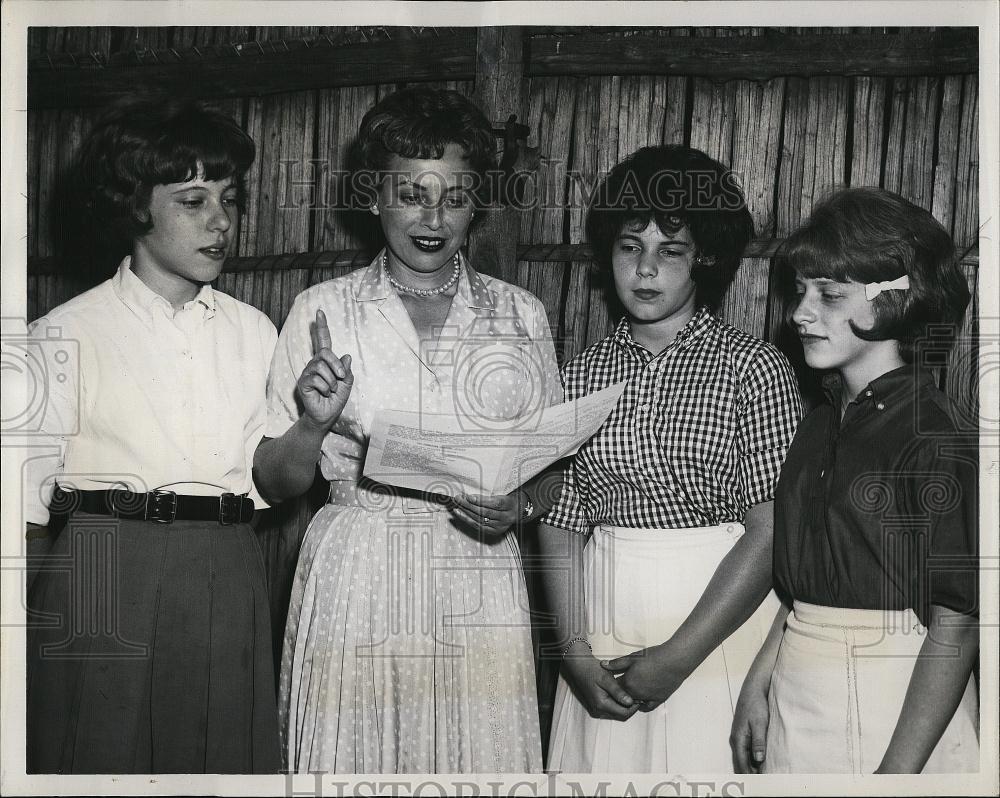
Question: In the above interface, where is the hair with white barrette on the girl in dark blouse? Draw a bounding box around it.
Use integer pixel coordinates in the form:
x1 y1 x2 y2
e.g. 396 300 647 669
775 188 971 362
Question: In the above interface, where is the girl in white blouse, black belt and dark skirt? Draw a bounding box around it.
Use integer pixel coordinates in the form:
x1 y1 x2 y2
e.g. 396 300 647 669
26 101 279 773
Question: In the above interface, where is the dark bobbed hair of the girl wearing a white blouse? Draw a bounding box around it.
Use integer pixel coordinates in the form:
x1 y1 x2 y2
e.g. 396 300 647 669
73 96 255 247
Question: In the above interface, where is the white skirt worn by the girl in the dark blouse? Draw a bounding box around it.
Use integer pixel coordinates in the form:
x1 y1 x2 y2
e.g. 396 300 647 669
763 601 979 775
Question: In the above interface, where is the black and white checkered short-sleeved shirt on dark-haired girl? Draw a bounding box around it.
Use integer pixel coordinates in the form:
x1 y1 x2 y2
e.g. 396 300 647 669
545 308 801 532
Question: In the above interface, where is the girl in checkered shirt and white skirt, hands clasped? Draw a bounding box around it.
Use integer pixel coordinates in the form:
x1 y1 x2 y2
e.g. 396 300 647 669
540 146 800 773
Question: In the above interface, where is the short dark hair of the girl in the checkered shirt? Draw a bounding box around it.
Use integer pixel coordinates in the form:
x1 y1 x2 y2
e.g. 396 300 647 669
587 144 753 310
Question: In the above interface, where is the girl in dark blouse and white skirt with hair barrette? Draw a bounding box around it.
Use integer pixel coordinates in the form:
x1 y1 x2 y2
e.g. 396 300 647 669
731 189 979 774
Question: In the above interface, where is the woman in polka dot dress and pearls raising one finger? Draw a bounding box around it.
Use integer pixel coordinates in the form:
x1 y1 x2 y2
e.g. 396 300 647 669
256 88 562 773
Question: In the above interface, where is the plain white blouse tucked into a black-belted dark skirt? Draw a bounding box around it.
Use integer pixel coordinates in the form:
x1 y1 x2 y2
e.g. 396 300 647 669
24 258 277 524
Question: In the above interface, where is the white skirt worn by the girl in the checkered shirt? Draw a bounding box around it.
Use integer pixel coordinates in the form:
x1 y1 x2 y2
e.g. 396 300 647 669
548 523 778 773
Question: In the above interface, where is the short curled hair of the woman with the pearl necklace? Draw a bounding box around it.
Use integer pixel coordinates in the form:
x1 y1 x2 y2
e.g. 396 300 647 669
352 86 497 202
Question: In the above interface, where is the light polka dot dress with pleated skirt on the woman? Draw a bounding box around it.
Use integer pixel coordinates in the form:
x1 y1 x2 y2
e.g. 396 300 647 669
268 252 562 773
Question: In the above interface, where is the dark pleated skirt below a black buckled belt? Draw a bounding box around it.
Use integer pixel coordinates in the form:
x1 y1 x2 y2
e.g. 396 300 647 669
26 513 280 773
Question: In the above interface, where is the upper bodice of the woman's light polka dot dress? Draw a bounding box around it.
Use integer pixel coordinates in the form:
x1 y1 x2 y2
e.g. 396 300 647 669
267 255 562 506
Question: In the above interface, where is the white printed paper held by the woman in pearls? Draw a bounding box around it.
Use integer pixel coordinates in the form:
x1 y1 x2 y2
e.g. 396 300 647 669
364 381 626 495
